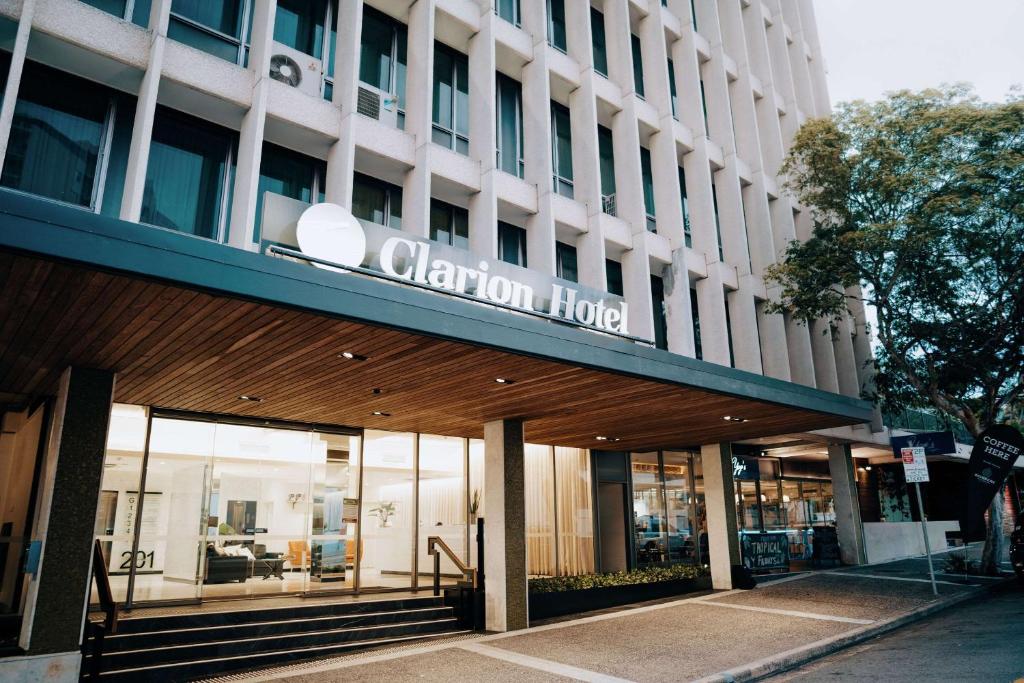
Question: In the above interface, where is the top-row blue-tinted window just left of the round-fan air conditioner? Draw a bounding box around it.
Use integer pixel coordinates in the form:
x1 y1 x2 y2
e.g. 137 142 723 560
167 0 253 65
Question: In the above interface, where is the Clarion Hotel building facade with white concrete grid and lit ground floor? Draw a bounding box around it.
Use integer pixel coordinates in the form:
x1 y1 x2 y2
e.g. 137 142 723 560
0 0 887 671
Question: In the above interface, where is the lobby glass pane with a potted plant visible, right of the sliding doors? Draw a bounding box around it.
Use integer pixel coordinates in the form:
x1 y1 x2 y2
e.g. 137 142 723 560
359 429 416 588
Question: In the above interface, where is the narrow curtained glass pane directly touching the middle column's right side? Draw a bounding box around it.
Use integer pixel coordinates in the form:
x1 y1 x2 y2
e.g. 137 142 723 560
528 443 557 577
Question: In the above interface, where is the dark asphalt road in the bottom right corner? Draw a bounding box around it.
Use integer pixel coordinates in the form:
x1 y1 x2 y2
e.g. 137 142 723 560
765 583 1024 683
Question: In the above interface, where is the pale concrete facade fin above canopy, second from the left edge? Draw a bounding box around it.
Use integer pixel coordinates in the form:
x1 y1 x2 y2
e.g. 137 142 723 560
121 0 171 222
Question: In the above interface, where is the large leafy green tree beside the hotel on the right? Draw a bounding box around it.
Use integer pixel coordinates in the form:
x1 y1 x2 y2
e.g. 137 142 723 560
767 86 1024 572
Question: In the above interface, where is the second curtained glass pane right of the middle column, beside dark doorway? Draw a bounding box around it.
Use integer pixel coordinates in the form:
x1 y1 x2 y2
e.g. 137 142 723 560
555 446 595 575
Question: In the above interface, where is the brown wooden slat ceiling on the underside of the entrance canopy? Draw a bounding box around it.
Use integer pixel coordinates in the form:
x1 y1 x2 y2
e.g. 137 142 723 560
0 253 851 450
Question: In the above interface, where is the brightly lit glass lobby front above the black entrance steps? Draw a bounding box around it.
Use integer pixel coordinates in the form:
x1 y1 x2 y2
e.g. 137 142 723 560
96 404 483 604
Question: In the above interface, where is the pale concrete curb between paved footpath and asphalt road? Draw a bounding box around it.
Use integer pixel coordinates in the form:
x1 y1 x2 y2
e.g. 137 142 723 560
692 578 1016 683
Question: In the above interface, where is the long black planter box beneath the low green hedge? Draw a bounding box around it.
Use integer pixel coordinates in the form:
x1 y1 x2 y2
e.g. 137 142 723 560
529 577 711 622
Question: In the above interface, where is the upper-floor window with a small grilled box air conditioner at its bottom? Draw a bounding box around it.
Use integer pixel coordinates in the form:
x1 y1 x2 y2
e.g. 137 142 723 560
358 7 407 128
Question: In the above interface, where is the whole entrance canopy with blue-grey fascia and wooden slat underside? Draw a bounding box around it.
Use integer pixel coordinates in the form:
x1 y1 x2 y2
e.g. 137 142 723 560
0 190 870 450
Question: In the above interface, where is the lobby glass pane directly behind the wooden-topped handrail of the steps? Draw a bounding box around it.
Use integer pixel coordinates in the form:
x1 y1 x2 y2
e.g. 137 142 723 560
417 434 467 586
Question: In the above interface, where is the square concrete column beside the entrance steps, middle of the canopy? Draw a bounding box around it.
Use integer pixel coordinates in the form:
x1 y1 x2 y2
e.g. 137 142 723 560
483 420 529 631
